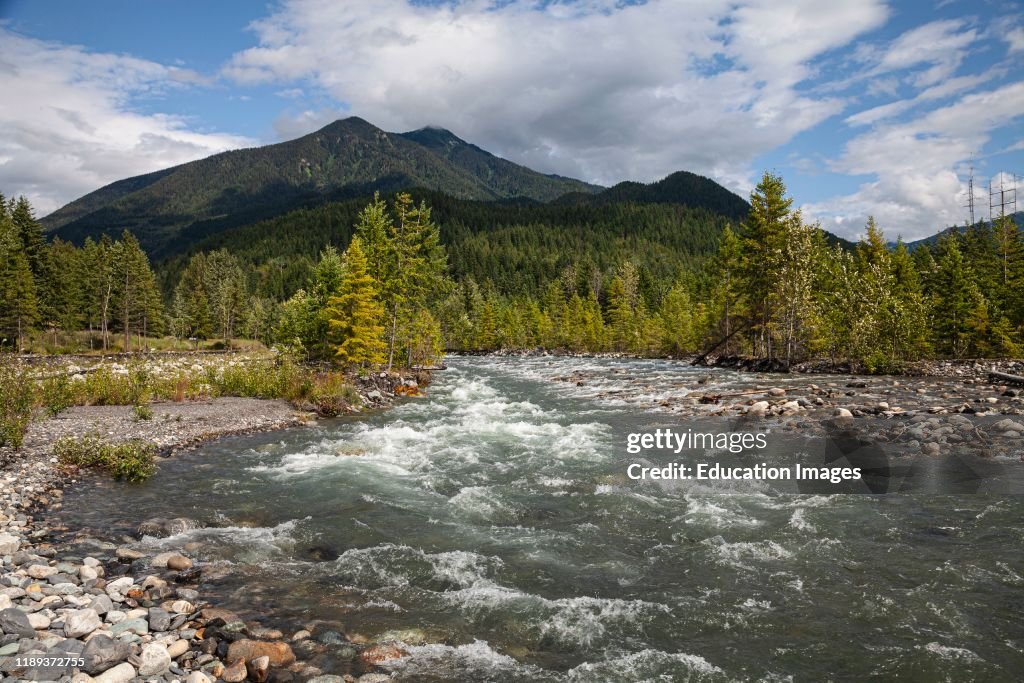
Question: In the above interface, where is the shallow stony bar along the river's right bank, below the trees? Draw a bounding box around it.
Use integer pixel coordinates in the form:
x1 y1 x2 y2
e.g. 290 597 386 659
553 361 1024 460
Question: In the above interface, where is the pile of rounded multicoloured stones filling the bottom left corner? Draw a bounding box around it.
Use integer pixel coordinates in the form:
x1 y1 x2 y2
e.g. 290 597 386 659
0 452 396 683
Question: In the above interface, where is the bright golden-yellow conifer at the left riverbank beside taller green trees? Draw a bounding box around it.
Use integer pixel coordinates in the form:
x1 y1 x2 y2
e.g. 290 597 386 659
327 237 387 367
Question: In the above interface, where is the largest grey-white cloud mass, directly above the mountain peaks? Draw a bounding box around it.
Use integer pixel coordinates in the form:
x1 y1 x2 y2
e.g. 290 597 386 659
224 0 887 190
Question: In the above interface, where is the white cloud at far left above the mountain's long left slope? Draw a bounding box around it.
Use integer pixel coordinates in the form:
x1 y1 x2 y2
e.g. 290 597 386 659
0 27 252 215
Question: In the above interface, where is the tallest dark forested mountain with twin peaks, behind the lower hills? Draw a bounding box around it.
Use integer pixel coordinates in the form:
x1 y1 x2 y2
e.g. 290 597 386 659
42 117 600 255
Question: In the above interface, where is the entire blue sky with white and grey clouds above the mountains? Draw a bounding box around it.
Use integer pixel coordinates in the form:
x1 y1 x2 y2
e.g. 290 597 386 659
0 0 1024 240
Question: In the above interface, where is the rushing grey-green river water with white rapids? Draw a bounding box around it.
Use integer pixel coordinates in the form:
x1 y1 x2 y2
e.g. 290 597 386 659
63 357 1024 682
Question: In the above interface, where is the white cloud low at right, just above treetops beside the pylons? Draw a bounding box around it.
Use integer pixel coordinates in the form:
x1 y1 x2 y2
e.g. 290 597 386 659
805 81 1024 240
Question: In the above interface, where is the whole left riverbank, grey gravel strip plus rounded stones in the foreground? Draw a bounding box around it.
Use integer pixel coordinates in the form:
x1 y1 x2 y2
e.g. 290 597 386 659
0 358 429 683
